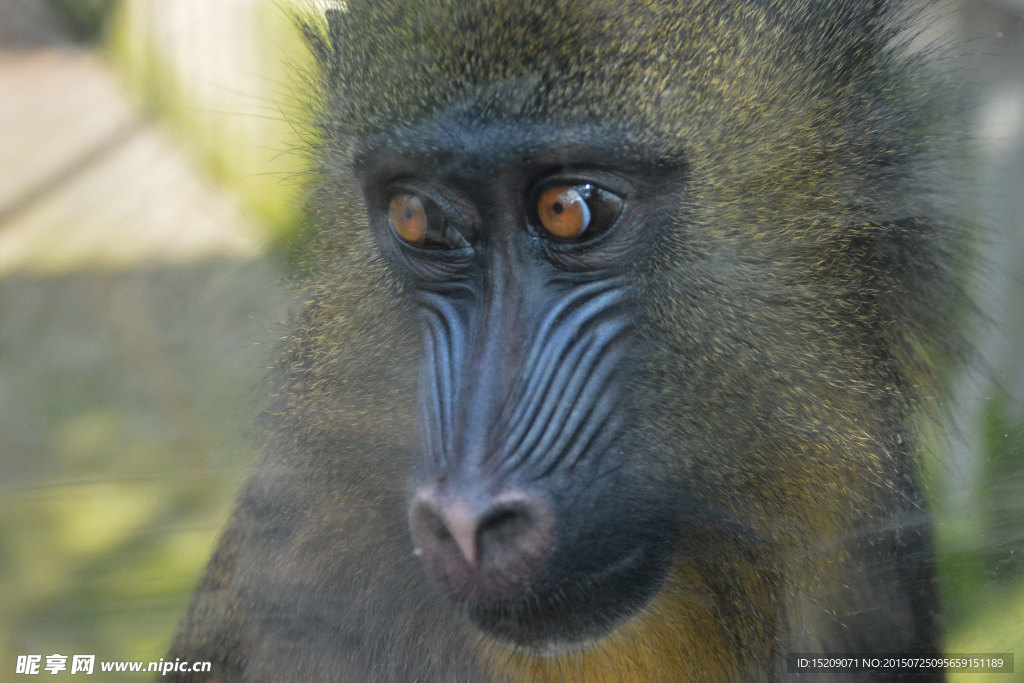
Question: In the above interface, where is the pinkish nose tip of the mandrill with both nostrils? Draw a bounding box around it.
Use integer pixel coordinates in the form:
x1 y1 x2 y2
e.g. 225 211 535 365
410 488 555 598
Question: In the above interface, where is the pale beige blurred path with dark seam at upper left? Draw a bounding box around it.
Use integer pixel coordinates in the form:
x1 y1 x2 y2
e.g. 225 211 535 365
0 0 259 273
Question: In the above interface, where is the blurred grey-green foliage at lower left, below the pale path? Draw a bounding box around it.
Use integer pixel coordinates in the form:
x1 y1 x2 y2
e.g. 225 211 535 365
0 259 283 680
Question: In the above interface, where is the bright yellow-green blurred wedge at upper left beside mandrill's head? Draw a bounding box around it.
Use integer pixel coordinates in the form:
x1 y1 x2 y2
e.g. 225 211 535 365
106 0 311 266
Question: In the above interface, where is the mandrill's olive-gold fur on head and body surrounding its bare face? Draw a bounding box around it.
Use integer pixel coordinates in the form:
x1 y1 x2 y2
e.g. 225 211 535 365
172 0 957 681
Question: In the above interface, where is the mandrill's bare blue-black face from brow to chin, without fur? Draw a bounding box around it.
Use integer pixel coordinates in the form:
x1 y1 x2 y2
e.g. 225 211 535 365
357 117 681 650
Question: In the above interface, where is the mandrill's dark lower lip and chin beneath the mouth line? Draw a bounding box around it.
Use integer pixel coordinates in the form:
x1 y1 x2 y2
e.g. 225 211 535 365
465 544 672 656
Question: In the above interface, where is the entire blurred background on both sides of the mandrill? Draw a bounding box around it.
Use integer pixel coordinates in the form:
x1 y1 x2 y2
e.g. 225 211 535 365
0 0 1024 681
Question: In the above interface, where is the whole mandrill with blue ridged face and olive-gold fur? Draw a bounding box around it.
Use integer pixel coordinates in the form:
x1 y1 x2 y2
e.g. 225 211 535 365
170 0 959 682
